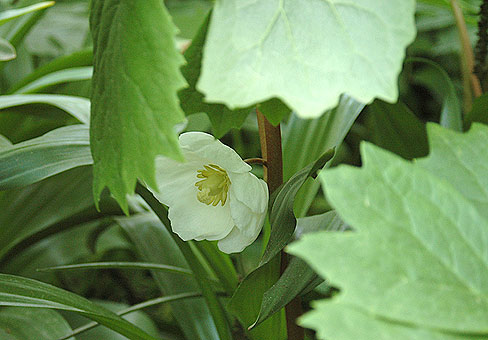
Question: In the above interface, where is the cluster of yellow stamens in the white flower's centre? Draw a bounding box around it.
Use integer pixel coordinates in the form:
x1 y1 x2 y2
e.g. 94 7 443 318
195 164 230 206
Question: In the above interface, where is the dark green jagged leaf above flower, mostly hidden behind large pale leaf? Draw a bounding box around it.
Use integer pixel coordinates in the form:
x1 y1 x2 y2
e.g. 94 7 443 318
178 12 251 138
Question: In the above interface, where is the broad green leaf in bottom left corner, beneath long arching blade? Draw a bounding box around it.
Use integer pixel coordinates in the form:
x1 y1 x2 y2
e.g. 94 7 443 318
0 307 75 340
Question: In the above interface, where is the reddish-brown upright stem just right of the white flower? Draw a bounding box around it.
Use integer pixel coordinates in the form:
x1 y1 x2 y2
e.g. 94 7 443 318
256 110 305 340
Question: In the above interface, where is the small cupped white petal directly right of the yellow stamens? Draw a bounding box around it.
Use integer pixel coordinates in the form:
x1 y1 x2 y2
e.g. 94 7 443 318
228 172 269 213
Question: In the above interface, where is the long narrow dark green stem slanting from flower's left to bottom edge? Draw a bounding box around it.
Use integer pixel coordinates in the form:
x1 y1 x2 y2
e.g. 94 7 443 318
136 183 232 340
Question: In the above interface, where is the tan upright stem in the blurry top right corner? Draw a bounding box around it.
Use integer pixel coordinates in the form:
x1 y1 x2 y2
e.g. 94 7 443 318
451 0 483 112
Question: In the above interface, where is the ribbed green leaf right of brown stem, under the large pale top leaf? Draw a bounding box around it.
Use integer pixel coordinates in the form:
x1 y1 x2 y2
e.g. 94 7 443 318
283 95 365 217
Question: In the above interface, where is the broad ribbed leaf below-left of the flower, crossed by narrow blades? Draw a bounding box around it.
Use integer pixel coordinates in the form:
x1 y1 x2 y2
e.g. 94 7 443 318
117 214 218 340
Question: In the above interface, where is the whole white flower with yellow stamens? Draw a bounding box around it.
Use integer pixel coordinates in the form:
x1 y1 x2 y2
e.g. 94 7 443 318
155 132 268 253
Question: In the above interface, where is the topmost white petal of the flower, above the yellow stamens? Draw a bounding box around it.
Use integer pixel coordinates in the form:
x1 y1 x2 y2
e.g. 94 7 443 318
180 132 252 173
